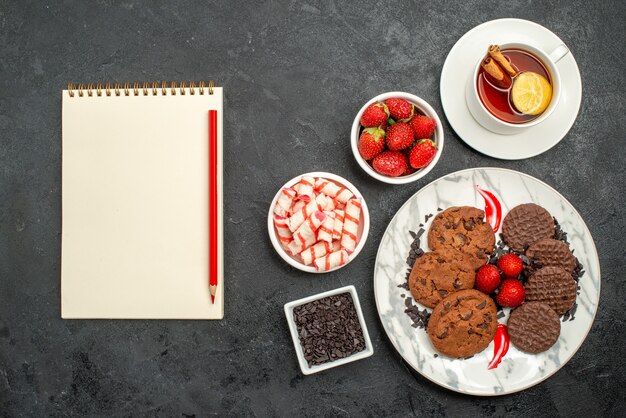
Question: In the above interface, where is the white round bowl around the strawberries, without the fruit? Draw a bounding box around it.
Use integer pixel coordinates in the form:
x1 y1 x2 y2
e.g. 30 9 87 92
350 91 444 184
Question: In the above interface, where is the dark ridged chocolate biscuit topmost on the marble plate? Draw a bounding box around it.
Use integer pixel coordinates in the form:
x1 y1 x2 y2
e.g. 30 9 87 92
502 203 554 252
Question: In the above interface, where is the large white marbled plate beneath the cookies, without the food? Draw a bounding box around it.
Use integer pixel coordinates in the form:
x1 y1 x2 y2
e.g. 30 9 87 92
374 168 600 396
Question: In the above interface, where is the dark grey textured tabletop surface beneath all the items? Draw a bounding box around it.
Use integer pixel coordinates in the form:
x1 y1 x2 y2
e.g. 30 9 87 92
0 0 626 416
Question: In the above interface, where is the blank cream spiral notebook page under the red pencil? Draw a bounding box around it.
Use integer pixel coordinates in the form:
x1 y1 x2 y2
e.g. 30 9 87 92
61 82 224 319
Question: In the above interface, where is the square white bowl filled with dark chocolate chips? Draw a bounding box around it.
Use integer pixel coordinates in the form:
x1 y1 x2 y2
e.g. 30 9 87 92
285 286 374 375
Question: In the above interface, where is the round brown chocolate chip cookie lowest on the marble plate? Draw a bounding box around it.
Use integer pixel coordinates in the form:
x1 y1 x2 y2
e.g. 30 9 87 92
428 289 498 358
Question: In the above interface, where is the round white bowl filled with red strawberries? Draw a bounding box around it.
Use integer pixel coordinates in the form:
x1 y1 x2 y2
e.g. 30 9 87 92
351 91 443 184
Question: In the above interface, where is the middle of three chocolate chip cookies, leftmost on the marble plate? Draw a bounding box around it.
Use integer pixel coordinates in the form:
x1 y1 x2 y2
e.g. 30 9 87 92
409 250 475 308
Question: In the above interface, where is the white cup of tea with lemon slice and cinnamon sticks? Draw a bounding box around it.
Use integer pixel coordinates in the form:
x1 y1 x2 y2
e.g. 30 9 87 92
465 43 569 135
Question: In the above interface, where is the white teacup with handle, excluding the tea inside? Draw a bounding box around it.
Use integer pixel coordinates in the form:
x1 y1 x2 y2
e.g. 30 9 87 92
465 43 569 135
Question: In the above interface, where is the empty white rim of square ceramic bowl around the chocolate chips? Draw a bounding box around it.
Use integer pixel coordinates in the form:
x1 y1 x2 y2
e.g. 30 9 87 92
285 286 374 374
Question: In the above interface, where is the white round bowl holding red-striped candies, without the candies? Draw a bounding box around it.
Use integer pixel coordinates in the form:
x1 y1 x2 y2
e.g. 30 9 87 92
267 171 370 273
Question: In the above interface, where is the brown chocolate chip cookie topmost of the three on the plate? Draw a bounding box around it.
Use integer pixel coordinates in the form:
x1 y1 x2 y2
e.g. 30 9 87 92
428 206 496 270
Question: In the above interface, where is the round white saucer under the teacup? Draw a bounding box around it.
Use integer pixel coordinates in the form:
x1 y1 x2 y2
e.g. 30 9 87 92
440 19 582 160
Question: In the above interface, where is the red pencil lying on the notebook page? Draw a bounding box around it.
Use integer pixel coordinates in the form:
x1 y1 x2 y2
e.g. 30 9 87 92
209 110 218 304
